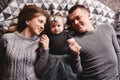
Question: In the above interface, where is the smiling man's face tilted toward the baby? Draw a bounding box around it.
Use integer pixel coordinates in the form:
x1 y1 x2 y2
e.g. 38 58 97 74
69 8 90 32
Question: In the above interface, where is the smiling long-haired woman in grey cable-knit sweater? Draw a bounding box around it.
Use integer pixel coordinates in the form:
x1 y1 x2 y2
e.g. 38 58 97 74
0 5 49 80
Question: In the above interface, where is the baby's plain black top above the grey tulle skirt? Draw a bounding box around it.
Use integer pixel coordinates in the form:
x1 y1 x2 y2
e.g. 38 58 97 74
48 32 72 55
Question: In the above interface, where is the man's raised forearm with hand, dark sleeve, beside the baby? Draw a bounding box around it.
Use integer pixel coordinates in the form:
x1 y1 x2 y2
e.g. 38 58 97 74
68 38 82 75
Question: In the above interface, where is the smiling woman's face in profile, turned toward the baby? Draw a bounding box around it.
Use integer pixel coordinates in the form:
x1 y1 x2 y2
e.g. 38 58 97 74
26 15 46 35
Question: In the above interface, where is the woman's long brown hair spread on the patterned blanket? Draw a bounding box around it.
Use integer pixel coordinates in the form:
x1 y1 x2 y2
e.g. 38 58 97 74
17 5 48 32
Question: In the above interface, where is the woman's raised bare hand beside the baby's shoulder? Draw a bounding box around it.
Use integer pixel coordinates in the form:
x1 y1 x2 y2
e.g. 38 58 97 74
40 34 49 50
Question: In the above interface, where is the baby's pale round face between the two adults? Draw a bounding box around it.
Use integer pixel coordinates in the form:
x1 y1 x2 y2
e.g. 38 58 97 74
50 16 64 34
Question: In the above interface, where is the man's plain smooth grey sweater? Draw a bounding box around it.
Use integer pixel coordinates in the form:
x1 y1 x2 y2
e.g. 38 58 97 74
74 24 120 80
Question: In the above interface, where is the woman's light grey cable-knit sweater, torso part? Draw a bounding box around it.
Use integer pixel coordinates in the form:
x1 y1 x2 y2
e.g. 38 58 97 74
2 32 39 80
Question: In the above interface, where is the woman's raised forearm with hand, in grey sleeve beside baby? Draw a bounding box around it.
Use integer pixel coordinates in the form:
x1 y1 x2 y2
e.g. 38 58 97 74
35 35 49 75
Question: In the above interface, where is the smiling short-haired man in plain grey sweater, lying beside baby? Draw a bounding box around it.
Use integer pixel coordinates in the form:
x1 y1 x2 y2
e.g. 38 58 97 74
68 5 120 80
